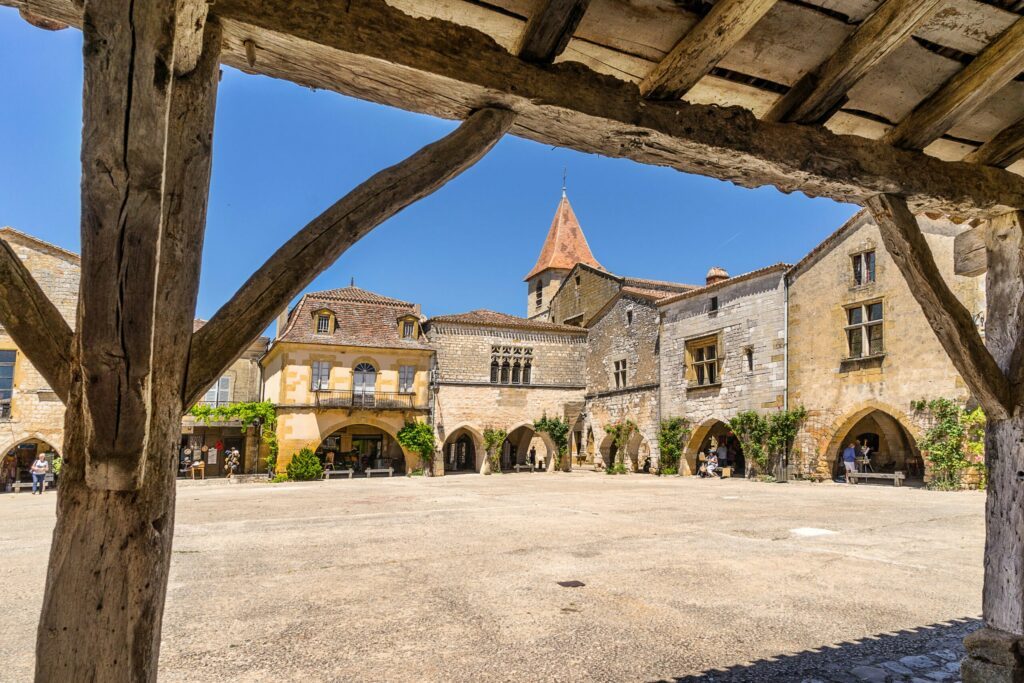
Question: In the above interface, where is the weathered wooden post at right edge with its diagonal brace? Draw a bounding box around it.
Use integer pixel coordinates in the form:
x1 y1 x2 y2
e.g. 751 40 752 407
867 196 1024 683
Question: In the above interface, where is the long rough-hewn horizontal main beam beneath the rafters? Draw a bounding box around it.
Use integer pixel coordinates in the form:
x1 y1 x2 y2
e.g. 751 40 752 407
9 0 1024 217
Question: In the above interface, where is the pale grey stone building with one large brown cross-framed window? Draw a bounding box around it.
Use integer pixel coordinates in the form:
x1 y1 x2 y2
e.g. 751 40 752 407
657 263 790 474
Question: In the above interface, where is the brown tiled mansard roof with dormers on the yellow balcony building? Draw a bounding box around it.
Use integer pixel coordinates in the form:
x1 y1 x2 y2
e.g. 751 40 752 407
280 287 430 349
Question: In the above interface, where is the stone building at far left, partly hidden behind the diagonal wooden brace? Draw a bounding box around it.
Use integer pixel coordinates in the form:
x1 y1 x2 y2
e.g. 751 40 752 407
0 227 81 490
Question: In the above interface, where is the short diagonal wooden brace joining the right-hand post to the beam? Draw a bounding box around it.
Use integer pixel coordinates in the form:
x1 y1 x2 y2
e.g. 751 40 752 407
866 195 1012 419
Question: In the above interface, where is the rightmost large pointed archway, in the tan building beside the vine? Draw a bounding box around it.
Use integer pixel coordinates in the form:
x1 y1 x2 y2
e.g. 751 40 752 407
822 404 924 483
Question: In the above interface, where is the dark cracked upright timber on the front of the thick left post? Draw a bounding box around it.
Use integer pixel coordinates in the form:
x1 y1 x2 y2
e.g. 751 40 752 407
78 0 216 490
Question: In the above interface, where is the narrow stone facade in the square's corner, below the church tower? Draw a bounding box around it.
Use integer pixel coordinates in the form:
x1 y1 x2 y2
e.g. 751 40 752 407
577 288 659 471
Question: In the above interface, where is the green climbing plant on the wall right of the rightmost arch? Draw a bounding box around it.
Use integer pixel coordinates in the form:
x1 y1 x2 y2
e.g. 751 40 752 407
912 398 987 488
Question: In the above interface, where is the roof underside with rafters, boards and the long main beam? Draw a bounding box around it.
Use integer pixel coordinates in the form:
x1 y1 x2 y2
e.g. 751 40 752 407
12 0 1024 216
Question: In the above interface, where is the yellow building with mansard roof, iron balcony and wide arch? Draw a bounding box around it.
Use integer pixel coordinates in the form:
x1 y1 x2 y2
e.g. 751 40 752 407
261 286 433 473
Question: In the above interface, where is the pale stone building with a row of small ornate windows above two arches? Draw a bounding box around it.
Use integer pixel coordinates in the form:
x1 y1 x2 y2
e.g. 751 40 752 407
425 310 587 472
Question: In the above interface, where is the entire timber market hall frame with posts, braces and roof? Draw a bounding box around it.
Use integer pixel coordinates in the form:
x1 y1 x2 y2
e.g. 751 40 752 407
6 0 1024 681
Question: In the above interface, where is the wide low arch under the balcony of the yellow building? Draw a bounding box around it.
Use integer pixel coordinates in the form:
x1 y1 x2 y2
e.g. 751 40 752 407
315 418 409 474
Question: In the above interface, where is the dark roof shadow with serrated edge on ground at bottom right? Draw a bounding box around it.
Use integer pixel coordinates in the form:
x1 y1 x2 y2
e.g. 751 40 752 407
660 617 982 683
